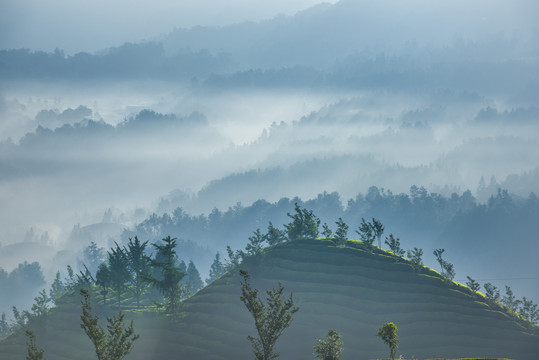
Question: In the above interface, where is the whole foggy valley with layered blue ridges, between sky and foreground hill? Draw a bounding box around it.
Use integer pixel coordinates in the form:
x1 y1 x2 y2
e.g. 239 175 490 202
0 0 539 320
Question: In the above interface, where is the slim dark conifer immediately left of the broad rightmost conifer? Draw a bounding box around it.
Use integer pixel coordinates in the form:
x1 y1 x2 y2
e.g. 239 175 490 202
125 236 150 308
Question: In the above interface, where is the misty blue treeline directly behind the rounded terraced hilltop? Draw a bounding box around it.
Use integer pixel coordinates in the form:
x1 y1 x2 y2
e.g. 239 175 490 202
122 186 539 255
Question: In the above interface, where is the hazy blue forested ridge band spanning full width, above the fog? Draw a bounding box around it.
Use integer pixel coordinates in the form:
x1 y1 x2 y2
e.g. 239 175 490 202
0 42 539 91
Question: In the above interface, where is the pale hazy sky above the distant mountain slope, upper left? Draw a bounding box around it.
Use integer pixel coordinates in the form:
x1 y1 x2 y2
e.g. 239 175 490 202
0 0 336 53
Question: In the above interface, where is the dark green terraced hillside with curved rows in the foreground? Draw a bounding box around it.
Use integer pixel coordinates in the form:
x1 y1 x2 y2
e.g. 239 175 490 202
0 240 539 360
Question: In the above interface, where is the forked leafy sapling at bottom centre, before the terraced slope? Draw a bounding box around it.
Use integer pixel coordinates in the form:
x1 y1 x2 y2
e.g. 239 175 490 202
240 270 299 360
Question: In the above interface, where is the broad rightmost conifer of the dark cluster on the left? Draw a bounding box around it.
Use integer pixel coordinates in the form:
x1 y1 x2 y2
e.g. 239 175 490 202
146 236 185 319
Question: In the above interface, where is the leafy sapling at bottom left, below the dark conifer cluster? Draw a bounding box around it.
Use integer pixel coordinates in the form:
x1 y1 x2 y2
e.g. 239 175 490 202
80 290 140 360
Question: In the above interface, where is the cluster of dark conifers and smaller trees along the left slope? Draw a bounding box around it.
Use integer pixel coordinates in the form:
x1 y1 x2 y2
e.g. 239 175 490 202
0 236 209 339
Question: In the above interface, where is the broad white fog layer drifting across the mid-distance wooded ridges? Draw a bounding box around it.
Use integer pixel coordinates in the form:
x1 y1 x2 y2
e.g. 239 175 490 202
0 84 539 265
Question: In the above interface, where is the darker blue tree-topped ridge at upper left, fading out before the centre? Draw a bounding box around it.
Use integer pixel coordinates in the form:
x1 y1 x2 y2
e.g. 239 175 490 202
0 42 236 80
